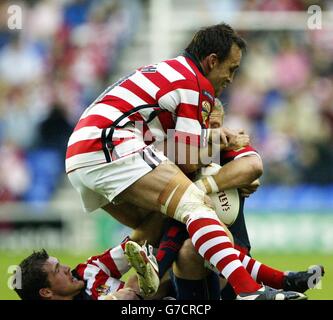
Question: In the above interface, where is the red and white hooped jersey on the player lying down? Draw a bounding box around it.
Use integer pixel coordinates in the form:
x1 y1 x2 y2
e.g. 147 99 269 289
72 242 131 300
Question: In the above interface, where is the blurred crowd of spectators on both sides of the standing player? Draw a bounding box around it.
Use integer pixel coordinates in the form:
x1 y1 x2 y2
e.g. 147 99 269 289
0 0 333 201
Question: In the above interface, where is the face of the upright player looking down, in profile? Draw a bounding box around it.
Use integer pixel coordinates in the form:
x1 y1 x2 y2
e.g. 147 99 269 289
207 44 242 97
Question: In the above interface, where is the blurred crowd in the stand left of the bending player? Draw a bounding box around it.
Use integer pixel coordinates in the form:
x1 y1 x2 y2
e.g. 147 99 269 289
0 0 141 201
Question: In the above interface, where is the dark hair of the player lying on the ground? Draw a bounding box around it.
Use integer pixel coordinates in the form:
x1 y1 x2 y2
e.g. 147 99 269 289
15 249 50 300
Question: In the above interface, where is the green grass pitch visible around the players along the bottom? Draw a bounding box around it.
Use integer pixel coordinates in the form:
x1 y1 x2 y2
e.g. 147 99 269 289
0 251 333 300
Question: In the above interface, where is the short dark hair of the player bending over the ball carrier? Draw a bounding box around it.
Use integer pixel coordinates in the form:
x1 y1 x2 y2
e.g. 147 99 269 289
185 23 246 62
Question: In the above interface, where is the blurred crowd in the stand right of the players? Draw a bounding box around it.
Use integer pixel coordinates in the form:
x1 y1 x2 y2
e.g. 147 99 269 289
203 0 333 186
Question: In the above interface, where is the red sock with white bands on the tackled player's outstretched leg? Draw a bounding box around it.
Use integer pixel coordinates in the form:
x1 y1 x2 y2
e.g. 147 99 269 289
235 249 284 289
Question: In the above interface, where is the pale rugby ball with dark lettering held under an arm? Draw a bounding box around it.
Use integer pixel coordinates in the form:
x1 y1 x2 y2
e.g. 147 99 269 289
196 163 240 226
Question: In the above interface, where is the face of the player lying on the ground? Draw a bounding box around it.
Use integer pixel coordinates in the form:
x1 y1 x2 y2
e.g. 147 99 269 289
44 257 84 299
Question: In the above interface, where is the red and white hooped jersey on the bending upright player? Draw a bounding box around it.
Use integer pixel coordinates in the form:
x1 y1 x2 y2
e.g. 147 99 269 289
66 55 214 172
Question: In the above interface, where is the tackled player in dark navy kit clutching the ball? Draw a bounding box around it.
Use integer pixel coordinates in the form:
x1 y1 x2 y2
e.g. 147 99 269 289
135 99 324 300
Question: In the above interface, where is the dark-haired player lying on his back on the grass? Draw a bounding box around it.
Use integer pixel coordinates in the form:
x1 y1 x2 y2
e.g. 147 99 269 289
15 239 159 300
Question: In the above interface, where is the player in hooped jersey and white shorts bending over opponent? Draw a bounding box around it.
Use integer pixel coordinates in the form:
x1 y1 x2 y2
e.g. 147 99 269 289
66 23 302 299
